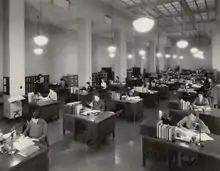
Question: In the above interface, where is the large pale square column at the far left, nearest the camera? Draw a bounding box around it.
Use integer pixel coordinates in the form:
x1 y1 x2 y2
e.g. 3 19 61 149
3 0 25 96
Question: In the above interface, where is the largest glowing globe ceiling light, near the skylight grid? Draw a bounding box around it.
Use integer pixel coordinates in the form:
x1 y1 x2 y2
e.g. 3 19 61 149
133 17 155 33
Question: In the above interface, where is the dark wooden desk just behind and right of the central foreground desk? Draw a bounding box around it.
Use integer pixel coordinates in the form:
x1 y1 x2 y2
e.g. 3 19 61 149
106 99 143 122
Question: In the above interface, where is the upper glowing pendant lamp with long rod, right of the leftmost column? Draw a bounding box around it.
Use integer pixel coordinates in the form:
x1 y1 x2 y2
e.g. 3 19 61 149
34 0 49 46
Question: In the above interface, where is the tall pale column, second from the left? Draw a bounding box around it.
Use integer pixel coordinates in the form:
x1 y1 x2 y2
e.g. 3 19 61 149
78 19 92 86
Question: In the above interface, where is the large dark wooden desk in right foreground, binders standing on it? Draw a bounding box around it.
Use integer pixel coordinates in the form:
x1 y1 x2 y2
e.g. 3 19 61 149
140 120 220 171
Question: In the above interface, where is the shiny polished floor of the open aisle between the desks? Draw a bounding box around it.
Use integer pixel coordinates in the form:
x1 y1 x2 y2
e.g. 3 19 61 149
0 89 219 171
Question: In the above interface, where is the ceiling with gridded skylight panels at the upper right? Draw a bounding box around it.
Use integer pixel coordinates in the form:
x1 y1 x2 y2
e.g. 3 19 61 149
101 0 220 38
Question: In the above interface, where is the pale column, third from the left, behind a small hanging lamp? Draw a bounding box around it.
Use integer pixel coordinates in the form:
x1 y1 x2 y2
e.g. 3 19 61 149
115 30 127 81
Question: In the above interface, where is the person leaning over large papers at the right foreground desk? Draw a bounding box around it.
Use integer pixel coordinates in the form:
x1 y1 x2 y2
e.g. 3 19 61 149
177 106 210 134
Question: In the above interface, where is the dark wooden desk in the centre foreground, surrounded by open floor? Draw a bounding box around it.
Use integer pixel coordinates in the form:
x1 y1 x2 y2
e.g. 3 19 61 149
63 112 115 145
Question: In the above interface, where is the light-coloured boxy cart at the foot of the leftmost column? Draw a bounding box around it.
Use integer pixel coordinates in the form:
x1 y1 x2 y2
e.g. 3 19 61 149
3 95 25 119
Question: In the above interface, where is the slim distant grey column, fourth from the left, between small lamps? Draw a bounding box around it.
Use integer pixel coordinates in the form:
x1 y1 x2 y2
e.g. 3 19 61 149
147 40 156 73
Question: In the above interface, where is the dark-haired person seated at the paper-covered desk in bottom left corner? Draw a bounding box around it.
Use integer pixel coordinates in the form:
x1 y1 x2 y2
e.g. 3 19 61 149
24 111 47 145
